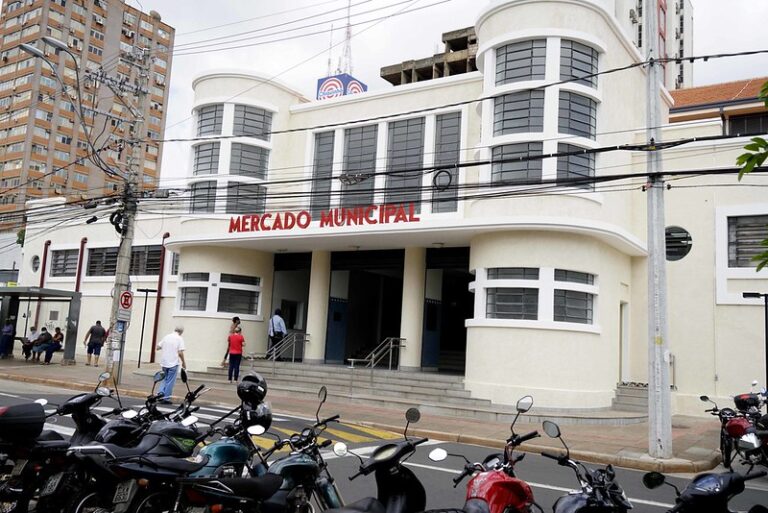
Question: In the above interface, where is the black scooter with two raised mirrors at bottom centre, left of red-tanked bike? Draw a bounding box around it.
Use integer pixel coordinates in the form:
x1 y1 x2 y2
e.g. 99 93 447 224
325 408 428 513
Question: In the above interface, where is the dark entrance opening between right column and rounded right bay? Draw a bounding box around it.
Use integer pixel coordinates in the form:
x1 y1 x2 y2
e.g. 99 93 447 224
421 248 475 374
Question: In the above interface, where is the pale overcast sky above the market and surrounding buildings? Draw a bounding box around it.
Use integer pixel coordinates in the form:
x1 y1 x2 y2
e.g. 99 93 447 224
115 0 768 185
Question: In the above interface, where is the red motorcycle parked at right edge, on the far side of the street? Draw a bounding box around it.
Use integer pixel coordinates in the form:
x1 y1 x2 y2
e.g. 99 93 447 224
699 394 768 469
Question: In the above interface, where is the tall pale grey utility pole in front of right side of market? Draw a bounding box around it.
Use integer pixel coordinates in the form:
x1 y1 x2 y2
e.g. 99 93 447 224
643 0 672 458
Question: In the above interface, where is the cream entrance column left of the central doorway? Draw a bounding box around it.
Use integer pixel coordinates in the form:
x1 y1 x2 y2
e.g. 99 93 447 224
304 251 331 363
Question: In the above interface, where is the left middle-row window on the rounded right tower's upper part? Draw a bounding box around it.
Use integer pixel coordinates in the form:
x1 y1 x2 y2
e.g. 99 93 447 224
493 91 544 135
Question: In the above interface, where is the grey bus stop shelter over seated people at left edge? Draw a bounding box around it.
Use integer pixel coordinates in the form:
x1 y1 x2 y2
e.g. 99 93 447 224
0 287 81 365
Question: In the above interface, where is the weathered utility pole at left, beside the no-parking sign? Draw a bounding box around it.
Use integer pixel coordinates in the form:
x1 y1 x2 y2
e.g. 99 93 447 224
102 46 149 384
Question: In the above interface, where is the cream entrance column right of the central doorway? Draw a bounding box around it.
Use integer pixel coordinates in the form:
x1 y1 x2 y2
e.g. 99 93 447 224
400 248 427 370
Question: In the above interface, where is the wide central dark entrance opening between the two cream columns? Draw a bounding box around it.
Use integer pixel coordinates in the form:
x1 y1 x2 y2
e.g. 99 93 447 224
325 250 404 363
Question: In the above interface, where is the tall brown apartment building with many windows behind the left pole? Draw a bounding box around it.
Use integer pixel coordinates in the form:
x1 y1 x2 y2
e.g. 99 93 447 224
0 0 174 223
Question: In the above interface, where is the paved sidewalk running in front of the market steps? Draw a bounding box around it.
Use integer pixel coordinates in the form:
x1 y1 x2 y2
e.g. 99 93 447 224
0 358 720 473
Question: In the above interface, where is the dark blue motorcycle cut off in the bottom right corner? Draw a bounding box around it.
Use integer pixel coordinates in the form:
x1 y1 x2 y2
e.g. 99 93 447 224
643 470 768 513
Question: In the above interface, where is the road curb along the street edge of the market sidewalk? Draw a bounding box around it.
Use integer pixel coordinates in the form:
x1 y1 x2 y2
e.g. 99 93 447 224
0 372 721 473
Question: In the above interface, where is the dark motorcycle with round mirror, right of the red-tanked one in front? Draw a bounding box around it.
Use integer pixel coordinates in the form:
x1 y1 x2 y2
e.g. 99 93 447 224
541 420 632 513
